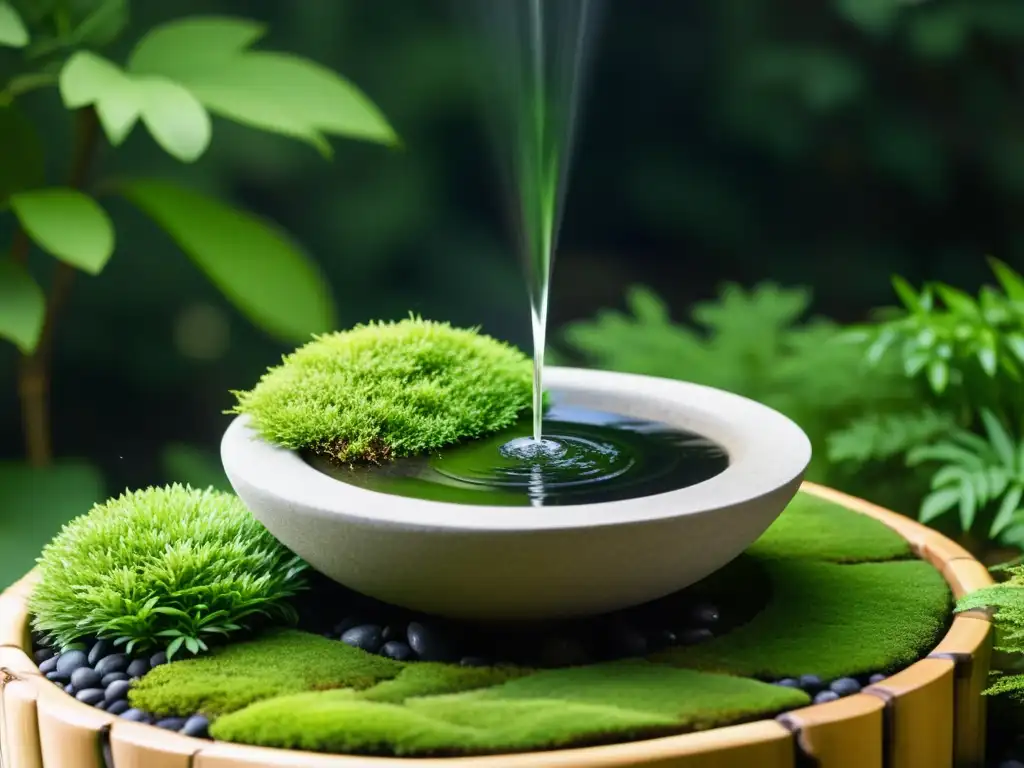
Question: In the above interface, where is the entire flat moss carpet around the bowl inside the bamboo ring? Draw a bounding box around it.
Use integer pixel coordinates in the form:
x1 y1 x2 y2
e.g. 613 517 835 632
125 496 950 756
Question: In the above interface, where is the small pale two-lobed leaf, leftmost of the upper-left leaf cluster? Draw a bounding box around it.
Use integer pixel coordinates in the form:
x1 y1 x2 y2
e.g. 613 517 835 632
59 51 140 146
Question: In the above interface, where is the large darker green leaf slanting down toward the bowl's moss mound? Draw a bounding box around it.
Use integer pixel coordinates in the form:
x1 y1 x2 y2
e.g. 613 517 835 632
122 181 334 341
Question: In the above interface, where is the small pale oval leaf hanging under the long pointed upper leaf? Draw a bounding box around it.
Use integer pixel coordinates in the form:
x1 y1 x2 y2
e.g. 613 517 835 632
135 77 212 163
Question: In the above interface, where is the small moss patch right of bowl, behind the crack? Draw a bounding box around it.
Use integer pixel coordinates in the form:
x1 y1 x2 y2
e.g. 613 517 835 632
746 494 911 563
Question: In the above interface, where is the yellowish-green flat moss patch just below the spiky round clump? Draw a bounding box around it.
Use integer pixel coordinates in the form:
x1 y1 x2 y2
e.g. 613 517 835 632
128 630 402 716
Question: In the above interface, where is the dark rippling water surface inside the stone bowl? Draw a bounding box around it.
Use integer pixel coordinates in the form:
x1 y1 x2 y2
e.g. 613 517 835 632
306 404 729 507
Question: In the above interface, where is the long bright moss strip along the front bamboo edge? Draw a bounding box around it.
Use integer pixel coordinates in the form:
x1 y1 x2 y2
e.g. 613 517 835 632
211 662 809 756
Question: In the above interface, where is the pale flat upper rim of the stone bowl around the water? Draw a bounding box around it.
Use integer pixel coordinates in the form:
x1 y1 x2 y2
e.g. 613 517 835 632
221 367 811 532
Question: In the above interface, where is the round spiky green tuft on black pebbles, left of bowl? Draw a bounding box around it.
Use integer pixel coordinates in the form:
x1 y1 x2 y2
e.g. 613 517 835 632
29 485 306 656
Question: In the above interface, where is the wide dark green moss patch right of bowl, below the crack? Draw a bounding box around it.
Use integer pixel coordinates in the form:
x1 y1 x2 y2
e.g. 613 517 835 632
652 559 950 679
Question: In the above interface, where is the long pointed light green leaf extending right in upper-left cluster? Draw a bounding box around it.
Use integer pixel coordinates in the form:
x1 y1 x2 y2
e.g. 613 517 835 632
185 52 397 144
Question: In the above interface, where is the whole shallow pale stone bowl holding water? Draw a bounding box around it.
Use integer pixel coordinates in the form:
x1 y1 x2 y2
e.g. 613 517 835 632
221 368 811 621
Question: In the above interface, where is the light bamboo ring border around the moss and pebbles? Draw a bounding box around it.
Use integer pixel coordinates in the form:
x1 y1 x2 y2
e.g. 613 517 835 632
0 482 992 768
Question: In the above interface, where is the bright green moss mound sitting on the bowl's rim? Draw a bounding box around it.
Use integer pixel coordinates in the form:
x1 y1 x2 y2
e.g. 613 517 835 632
231 317 532 463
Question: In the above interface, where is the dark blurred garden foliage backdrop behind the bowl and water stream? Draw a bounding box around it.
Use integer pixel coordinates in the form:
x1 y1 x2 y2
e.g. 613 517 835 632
0 0 1024 581
